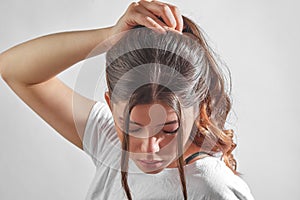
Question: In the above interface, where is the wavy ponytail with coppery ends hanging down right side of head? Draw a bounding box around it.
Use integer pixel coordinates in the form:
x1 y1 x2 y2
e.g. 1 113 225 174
182 16 239 174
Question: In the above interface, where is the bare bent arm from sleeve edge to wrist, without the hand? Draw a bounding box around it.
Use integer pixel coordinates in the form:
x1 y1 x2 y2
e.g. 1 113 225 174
0 28 111 148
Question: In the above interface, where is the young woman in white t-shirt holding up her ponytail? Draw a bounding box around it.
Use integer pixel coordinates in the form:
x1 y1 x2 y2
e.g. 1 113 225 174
0 1 253 199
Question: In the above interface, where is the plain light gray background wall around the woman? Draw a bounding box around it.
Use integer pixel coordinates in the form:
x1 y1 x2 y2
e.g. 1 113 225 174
0 0 300 200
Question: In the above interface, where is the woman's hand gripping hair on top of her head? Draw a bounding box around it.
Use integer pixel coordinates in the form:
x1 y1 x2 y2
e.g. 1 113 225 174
111 0 183 41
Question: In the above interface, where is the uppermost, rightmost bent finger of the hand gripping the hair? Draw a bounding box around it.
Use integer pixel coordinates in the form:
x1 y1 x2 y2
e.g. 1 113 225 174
139 1 177 28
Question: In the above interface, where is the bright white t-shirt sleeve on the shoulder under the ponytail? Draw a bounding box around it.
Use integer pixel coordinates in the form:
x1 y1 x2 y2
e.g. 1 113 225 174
189 156 254 200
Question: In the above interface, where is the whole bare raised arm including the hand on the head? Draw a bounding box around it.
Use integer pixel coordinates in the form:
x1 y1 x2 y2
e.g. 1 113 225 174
0 1 182 149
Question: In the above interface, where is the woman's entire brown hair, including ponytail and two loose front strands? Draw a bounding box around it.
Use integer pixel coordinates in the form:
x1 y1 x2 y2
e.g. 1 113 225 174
106 17 238 199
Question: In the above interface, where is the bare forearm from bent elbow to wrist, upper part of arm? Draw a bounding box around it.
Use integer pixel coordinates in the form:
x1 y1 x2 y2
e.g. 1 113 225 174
0 28 111 85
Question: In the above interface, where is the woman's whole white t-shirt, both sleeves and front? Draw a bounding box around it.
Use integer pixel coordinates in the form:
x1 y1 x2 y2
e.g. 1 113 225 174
83 102 254 200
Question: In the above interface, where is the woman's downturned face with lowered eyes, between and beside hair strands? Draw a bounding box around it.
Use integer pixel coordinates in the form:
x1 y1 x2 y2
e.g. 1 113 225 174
113 103 194 173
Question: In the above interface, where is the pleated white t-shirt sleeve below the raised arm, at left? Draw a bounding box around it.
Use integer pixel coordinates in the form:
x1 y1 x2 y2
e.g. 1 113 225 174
82 102 120 166
